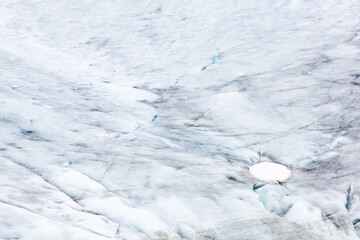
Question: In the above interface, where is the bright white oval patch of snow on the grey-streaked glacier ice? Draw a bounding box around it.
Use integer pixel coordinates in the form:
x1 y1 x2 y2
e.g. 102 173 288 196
249 162 291 183
